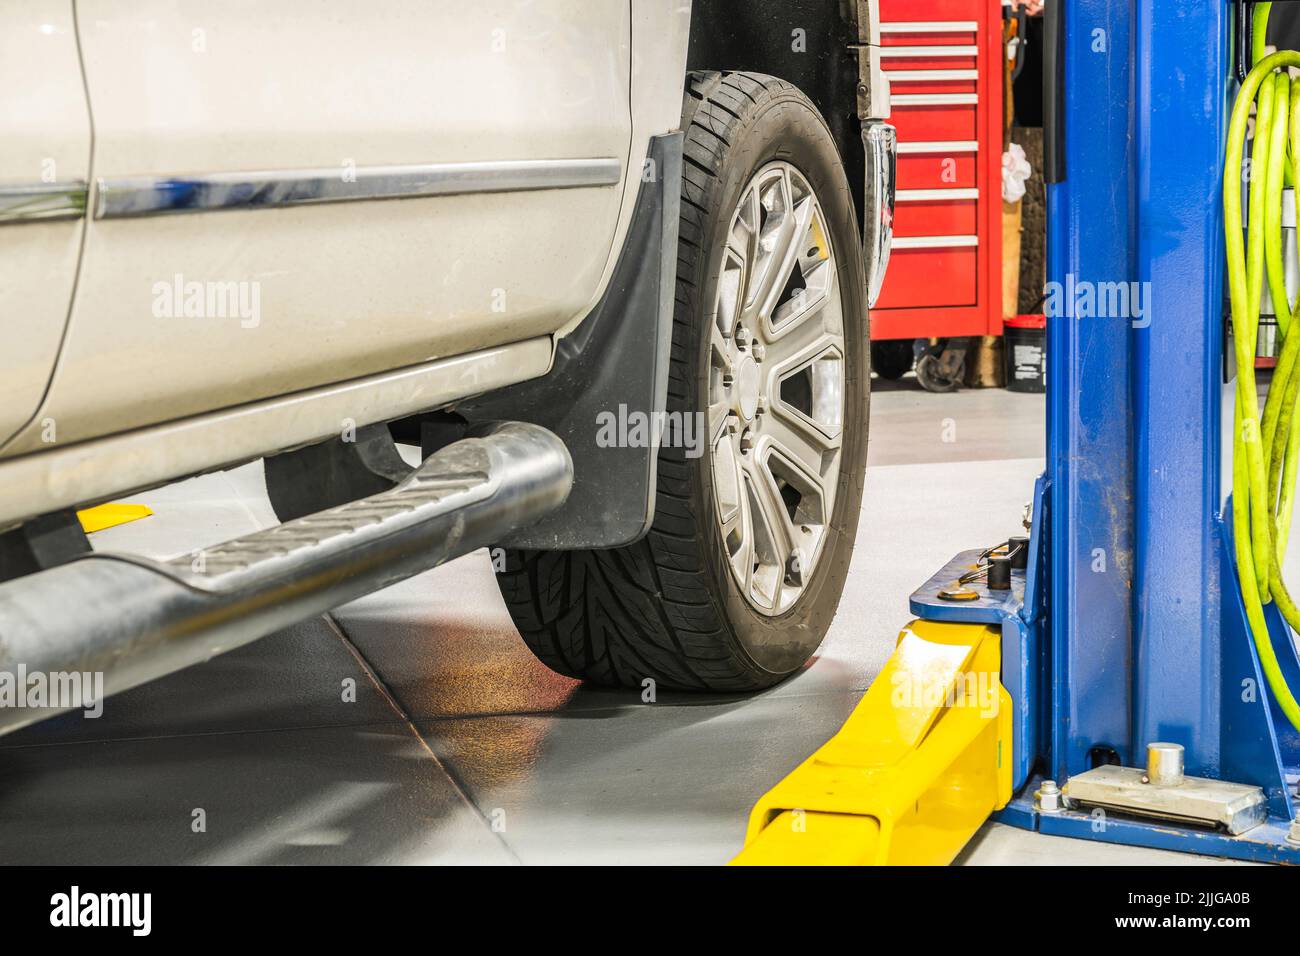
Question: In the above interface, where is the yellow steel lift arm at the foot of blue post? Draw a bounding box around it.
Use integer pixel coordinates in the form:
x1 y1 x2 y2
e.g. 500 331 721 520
732 620 1013 866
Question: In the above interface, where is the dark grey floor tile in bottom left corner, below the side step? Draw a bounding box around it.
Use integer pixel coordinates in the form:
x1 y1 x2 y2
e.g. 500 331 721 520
0 724 515 865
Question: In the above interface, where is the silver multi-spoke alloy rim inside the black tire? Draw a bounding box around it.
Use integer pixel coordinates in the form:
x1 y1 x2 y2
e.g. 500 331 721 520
709 163 845 615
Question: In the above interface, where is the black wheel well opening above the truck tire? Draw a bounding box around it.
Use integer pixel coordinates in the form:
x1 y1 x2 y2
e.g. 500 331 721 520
686 0 871 225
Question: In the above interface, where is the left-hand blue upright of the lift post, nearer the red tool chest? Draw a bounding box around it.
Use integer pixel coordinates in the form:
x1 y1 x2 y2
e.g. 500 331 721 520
1048 0 1133 779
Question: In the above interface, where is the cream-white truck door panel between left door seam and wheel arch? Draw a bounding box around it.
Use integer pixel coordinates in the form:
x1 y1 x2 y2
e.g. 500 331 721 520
21 0 631 449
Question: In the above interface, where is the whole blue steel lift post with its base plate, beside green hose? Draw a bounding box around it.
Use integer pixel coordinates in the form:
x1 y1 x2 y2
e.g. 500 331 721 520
911 0 1300 862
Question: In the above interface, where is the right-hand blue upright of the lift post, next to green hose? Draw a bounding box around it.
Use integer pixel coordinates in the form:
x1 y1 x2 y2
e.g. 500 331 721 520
1132 0 1232 775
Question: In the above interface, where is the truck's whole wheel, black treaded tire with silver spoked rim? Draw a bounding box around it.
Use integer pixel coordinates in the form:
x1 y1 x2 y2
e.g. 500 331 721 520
497 73 870 692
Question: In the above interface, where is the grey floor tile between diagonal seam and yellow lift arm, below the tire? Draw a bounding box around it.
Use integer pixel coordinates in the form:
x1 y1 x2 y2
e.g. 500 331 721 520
419 695 854 865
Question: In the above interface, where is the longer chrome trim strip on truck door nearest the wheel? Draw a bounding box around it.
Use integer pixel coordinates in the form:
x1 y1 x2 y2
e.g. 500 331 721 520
95 157 623 219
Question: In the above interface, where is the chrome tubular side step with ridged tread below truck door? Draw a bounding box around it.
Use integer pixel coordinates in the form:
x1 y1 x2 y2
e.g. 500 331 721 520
0 423 573 734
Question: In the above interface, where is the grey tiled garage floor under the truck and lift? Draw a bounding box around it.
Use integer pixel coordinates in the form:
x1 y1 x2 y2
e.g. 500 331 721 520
0 380 1258 865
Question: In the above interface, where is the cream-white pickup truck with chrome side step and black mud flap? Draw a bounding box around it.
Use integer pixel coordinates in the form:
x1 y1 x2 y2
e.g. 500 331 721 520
0 0 894 731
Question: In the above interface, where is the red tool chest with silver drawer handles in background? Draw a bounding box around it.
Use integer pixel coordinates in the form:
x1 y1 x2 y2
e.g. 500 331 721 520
871 0 1004 339
